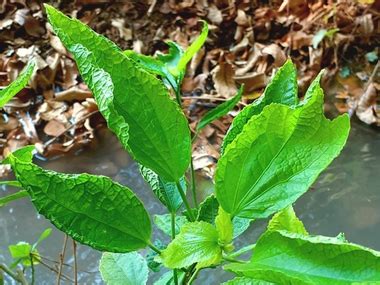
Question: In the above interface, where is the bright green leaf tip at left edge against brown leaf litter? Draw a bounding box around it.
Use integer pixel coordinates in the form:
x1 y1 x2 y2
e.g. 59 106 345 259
0 61 35 108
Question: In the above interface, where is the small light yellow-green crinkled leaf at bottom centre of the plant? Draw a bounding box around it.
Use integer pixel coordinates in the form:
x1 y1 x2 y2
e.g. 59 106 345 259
160 222 222 268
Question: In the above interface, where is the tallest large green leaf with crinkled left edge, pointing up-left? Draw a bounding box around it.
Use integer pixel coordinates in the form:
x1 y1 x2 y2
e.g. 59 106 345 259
45 5 191 181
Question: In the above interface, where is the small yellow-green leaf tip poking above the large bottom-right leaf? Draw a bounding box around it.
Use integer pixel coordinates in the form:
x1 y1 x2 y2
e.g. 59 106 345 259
267 206 308 235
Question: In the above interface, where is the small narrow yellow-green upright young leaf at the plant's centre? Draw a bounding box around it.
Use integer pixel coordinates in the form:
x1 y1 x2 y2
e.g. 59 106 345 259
215 207 234 252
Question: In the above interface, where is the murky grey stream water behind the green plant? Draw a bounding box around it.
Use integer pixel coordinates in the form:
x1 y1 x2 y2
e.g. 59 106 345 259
0 116 380 284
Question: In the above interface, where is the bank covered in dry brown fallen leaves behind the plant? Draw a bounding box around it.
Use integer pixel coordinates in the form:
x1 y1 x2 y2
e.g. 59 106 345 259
0 0 380 177
